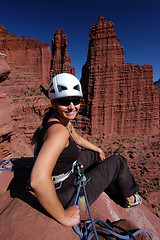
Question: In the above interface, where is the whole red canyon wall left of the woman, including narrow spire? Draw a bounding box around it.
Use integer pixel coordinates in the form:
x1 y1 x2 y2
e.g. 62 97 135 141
0 25 75 158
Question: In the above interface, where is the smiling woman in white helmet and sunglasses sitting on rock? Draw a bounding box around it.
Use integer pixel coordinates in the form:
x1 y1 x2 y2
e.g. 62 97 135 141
30 73 141 226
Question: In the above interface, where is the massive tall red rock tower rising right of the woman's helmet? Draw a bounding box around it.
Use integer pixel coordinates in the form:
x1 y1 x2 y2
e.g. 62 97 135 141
81 17 159 136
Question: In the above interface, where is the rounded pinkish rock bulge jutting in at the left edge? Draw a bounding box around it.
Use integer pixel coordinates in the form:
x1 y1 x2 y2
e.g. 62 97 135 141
0 53 10 83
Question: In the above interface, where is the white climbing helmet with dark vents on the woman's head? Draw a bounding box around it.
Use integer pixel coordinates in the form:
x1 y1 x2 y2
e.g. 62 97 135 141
48 73 83 99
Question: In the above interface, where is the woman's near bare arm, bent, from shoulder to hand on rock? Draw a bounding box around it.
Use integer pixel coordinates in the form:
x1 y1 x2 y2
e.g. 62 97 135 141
31 124 79 226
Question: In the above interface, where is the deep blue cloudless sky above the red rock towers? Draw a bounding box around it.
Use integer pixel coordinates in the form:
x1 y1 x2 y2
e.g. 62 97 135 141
0 0 160 81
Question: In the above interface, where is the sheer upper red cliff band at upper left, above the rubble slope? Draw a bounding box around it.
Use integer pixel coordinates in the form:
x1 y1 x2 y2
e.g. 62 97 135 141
0 25 51 82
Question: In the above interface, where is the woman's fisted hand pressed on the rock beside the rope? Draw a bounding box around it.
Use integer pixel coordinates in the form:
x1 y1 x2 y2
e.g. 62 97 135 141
62 206 80 227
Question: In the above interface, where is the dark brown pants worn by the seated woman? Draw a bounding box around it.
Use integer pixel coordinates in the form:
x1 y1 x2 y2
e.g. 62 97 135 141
57 150 139 207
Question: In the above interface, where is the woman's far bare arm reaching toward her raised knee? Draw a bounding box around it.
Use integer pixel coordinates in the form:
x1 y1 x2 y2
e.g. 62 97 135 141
72 124 105 161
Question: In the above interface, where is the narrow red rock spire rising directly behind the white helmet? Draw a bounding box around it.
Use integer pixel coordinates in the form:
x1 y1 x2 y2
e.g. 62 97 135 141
50 30 76 78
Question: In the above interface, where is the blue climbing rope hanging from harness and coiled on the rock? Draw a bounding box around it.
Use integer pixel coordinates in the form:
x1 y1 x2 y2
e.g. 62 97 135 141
73 163 152 240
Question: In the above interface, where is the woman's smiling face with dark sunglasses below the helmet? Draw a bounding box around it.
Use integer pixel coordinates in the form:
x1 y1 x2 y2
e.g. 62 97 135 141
52 97 80 121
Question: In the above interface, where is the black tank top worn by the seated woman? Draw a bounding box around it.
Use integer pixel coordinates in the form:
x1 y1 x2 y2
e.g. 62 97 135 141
36 121 79 175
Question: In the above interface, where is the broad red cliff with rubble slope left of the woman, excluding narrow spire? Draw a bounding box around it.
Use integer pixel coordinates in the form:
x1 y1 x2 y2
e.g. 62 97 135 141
0 25 51 159
